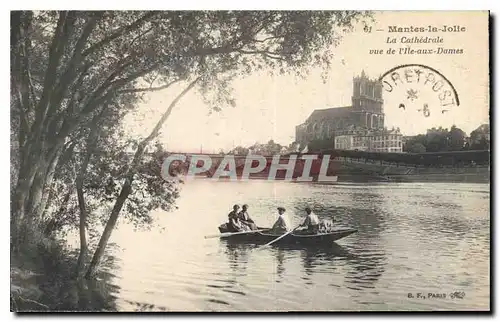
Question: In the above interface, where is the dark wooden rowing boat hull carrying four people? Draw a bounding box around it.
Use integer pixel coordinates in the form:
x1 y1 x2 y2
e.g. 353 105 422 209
219 224 357 245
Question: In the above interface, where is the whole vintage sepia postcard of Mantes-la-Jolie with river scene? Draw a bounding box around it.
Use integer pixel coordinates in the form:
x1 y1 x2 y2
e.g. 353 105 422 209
10 11 491 312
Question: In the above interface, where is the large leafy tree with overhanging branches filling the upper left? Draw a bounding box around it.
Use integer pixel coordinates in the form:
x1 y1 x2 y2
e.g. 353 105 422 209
11 11 369 275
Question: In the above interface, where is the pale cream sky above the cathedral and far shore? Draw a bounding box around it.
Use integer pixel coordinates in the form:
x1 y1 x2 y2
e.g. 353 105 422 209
126 11 489 153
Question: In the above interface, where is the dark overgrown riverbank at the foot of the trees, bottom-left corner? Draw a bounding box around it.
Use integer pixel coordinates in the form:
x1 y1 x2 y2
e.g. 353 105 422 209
10 231 116 313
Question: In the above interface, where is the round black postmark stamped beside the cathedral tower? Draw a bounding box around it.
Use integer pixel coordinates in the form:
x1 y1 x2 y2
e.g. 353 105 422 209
379 64 460 117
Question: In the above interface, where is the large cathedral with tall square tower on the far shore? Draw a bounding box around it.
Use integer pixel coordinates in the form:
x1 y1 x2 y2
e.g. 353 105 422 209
295 71 384 144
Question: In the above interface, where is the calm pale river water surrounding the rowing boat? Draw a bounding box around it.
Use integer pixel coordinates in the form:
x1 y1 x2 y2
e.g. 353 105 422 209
106 181 490 311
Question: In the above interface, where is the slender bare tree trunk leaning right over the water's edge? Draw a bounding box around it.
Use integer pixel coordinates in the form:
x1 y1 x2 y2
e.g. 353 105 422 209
85 78 199 279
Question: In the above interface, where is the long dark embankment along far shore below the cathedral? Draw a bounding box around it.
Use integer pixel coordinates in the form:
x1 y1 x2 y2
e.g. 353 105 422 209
162 150 490 178
